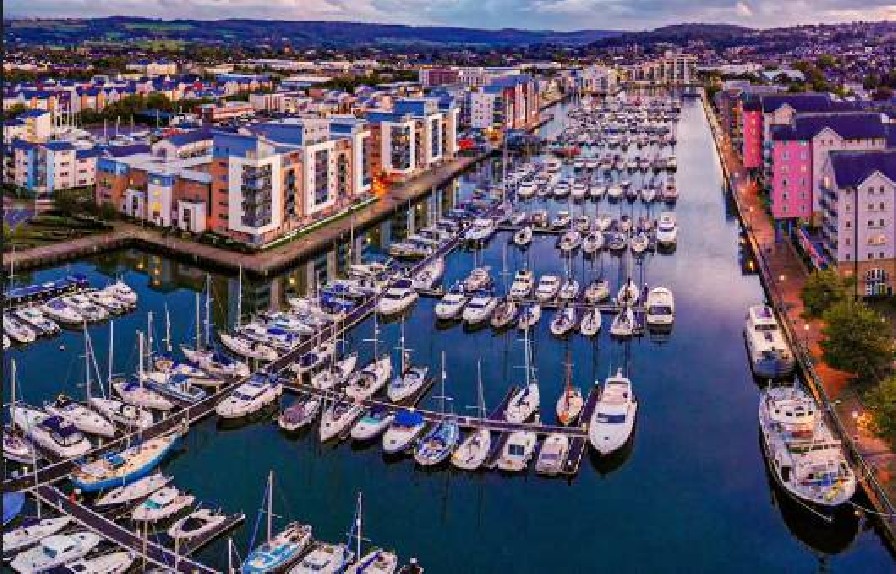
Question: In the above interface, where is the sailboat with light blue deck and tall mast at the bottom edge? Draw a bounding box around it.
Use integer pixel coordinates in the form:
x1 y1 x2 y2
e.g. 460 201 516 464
240 471 311 574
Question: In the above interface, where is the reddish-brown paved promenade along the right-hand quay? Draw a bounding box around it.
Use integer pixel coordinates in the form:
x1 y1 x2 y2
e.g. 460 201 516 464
704 95 896 545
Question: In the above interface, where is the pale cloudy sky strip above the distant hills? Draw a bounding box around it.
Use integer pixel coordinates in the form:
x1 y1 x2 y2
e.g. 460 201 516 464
3 0 896 30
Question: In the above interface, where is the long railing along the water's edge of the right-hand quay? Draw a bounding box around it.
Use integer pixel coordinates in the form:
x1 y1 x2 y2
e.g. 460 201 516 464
702 93 896 545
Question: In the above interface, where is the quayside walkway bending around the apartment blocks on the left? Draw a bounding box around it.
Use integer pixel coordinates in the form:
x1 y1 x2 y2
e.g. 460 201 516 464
3 152 492 277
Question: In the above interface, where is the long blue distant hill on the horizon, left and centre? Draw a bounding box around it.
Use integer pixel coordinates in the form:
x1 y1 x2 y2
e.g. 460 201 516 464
4 16 620 48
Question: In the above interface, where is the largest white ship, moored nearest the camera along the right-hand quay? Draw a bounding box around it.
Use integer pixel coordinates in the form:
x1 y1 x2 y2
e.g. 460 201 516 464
759 386 856 512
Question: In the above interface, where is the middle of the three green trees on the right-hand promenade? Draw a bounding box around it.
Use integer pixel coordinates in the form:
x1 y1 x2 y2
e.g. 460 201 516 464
821 299 894 379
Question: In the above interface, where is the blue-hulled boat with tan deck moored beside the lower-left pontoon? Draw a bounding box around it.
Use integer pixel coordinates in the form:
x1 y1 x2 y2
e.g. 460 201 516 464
71 433 180 492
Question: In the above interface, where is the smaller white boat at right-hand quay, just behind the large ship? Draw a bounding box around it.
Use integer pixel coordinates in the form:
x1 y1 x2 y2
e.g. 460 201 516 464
744 305 796 378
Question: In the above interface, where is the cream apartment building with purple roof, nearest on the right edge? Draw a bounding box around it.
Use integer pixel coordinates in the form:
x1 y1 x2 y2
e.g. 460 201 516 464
821 149 896 296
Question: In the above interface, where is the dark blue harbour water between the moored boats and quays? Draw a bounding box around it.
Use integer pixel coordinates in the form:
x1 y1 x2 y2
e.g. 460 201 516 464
4 101 894 574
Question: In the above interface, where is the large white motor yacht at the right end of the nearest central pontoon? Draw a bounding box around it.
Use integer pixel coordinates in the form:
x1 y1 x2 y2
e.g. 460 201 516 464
588 369 638 455
